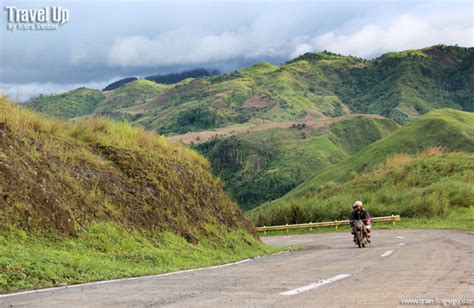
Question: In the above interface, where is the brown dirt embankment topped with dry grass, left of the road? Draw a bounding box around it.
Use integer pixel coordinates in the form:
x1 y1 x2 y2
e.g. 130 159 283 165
0 100 254 241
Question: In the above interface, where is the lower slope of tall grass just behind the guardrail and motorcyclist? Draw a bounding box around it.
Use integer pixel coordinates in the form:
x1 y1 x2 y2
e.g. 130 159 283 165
251 148 474 229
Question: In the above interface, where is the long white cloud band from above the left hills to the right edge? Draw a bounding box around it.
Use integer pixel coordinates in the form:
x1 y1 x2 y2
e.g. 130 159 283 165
108 8 474 68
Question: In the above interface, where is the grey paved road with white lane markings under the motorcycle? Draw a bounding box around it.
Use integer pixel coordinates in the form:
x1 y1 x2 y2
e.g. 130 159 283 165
0 230 474 307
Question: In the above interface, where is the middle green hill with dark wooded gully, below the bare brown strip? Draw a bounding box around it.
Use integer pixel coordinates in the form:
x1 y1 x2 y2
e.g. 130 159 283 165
195 116 397 210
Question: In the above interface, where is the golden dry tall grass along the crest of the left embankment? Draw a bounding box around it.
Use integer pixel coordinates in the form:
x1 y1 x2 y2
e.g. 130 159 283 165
0 96 208 168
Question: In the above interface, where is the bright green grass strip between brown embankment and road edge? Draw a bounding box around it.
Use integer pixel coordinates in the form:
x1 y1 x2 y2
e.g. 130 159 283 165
0 222 284 293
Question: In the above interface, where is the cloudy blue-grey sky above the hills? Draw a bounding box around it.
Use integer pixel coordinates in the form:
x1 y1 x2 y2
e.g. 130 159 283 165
0 0 474 101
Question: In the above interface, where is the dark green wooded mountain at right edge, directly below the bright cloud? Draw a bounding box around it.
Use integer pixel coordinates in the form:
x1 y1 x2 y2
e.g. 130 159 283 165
337 45 474 123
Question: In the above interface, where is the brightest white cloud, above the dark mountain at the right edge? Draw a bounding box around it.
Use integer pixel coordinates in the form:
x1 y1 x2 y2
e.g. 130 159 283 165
308 11 474 58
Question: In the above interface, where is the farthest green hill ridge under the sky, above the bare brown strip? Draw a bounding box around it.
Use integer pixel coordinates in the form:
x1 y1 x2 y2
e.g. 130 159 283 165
29 45 474 134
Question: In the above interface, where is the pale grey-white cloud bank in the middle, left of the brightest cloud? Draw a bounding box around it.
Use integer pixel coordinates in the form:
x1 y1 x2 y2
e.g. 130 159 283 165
108 16 296 68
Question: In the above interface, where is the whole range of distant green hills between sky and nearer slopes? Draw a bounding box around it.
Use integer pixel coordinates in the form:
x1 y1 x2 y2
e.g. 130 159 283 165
27 45 474 210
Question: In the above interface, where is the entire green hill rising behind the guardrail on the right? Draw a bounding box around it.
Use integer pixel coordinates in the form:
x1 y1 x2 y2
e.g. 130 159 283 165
251 109 474 225
